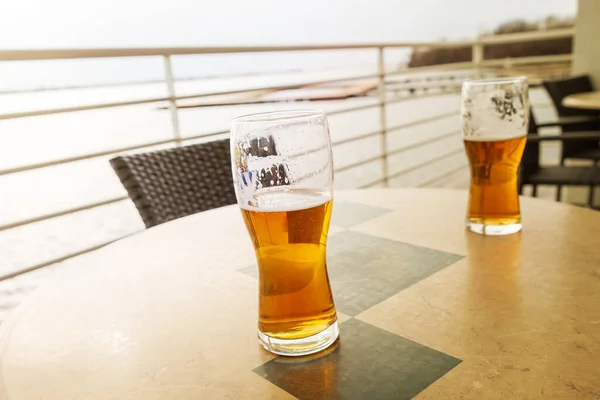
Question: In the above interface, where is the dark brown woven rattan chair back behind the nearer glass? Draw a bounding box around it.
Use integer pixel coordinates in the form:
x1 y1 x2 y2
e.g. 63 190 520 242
110 139 236 228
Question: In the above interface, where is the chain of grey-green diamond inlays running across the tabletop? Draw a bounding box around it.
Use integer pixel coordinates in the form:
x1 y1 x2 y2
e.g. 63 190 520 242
240 202 463 400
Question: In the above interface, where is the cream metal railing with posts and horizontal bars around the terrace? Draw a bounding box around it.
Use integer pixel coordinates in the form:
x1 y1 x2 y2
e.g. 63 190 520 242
0 29 573 280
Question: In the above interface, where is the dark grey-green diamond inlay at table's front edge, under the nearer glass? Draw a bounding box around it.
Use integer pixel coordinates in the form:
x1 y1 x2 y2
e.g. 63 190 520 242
254 319 461 400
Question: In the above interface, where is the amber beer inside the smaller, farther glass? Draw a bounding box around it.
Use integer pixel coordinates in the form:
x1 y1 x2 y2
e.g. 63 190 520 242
464 136 527 233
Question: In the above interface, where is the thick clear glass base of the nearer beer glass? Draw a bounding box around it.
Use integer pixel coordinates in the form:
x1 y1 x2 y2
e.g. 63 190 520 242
258 320 340 356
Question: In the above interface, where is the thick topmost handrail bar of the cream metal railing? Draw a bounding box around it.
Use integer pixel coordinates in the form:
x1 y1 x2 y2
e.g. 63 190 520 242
0 28 574 61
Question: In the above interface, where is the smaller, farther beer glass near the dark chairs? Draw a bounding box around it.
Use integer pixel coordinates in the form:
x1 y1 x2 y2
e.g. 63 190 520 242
461 77 529 235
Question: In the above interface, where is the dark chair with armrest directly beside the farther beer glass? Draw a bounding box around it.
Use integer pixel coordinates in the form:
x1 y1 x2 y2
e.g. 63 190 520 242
519 112 600 207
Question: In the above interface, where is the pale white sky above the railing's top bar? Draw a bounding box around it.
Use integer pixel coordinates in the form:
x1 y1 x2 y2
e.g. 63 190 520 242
0 0 577 49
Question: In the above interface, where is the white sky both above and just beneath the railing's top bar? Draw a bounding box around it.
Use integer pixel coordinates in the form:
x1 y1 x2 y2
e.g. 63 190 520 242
0 0 580 92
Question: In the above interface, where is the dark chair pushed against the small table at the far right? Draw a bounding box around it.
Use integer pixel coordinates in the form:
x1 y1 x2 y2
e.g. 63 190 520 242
539 75 600 165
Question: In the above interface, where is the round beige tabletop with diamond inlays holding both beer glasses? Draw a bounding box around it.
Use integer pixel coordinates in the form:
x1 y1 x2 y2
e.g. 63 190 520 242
0 189 600 400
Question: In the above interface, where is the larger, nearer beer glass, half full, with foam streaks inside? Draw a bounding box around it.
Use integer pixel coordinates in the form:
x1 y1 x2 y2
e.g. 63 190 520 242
231 110 339 356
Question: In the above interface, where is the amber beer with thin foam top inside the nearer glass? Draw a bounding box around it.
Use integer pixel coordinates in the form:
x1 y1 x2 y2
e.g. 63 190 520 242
242 188 336 340
